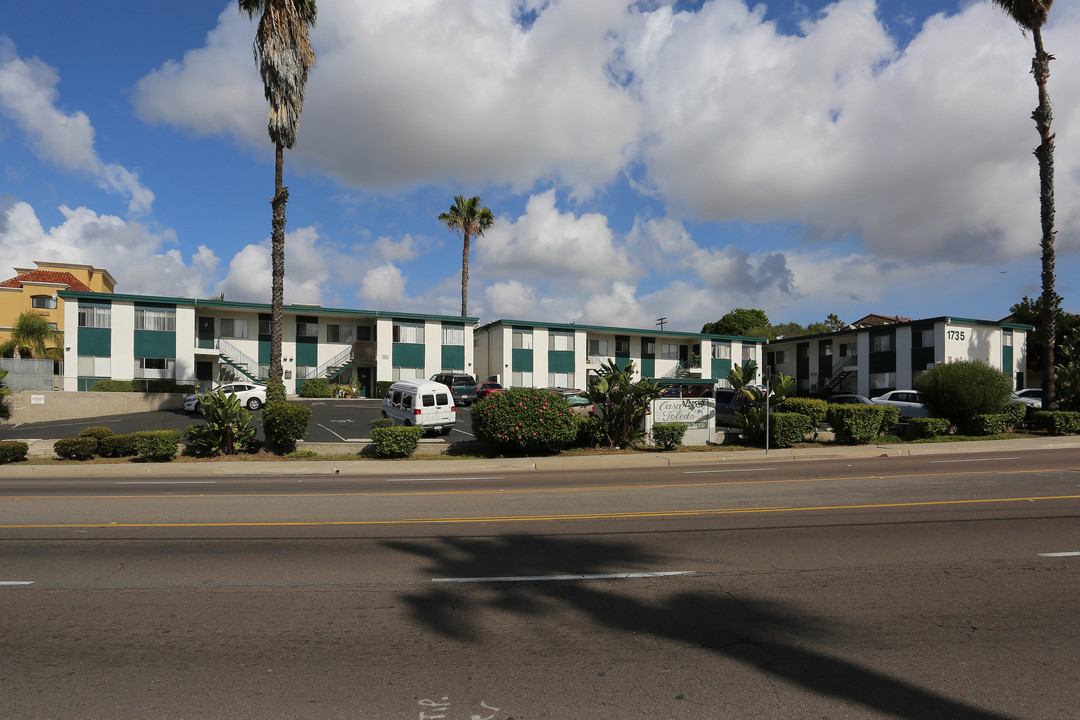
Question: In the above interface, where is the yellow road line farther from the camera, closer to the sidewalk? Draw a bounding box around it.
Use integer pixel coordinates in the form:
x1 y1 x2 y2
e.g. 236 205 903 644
0 467 1080 501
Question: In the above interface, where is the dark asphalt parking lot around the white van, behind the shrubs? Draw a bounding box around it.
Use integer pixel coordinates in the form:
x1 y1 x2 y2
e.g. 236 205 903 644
0 398 473 443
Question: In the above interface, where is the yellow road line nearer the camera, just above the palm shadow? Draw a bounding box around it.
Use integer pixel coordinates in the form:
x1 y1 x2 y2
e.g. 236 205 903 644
0 495 1080 530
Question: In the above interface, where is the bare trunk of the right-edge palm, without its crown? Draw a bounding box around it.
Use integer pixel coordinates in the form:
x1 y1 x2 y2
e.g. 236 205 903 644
1031 27 1058 410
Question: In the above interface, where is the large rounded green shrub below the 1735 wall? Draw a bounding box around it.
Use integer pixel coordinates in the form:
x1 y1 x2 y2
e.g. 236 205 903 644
915 361 1013 427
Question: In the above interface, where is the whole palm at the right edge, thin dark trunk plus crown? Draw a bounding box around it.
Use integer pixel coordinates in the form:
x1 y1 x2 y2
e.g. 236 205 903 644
990 0 1061 410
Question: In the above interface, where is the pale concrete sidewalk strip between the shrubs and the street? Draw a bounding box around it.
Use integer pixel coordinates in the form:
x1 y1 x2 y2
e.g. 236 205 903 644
0 436 1080 481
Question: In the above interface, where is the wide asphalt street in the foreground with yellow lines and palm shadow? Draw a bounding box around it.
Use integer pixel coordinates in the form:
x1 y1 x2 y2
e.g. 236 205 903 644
0 450 1080 720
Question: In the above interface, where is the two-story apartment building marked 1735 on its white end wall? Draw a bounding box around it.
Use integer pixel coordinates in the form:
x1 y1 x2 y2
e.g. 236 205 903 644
766 316 1031 397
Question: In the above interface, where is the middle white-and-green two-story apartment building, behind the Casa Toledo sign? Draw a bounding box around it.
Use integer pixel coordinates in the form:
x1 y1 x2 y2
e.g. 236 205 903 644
474 320 765 388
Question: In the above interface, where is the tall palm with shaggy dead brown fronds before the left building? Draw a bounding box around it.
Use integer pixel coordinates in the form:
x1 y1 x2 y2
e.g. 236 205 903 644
238 0 315 402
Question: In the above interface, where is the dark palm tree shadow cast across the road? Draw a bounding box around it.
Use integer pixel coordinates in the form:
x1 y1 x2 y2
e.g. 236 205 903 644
387 535 1008 720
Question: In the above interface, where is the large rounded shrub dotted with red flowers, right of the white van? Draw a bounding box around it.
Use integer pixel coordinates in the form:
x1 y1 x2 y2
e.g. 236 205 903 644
472 388 578 454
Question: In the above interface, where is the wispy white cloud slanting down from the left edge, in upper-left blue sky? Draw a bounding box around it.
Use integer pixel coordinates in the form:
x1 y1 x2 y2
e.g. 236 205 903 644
0 36 153 214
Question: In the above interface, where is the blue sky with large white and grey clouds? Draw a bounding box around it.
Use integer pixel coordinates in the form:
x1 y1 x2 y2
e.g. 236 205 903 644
0 0 1080 331
